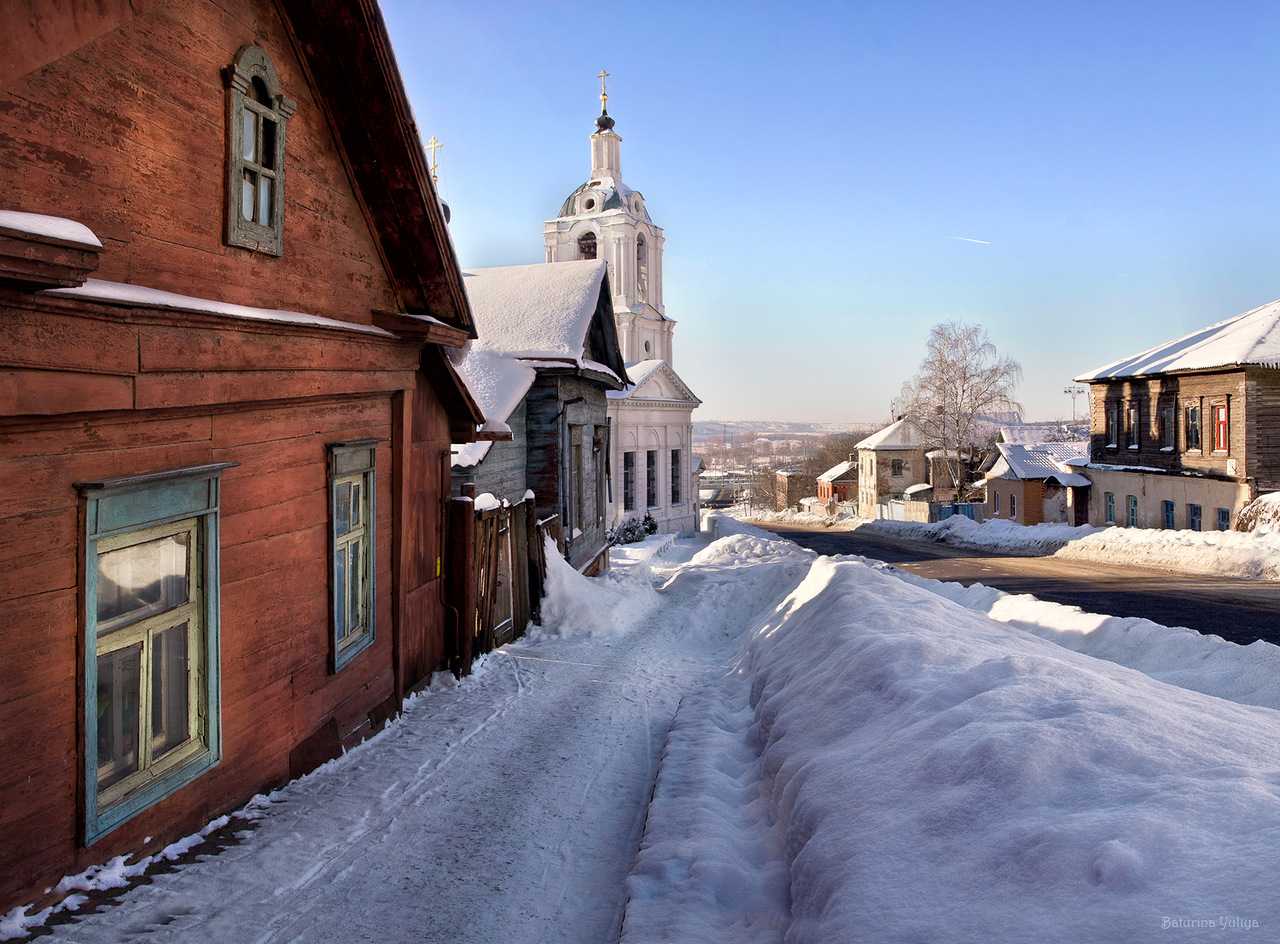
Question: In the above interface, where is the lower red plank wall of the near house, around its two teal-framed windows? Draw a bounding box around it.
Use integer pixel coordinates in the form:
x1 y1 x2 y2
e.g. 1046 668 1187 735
0 397 404 901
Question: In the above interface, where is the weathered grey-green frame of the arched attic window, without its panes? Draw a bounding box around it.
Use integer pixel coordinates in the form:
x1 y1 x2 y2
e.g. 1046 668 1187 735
223 43 297 256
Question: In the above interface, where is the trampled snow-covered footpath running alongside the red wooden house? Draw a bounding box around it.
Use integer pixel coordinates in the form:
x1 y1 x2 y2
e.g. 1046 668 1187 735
45 541 800 944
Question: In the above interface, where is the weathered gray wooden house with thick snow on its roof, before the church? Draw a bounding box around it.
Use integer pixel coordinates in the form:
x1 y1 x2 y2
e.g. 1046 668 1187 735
452 260 630 580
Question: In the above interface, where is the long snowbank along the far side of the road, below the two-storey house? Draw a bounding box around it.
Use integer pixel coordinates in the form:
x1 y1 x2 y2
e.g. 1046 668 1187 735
856 515 1280 581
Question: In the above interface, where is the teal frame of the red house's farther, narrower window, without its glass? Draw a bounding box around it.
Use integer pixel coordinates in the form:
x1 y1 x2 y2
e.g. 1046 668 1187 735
328 439 379 673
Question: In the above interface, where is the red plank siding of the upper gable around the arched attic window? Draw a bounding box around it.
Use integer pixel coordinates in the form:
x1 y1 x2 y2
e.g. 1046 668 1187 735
0 0 394 322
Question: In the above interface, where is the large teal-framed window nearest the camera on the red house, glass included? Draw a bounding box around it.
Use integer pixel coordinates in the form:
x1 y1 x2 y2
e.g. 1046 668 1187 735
77 463 234 846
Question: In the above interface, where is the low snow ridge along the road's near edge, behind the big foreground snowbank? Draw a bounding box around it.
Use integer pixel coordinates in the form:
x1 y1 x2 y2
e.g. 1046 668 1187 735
892 569 1280 709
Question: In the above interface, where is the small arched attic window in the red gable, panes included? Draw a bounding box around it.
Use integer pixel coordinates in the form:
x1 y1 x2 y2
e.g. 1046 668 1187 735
225 45 297 256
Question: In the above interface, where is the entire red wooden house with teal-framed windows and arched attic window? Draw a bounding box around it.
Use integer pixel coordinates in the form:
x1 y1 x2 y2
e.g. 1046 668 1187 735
0 0 481 913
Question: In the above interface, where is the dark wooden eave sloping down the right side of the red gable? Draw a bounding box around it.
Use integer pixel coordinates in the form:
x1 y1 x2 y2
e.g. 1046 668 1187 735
276 0 475 338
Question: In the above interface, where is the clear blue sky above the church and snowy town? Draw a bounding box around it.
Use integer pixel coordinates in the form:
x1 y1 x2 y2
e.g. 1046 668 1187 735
383 0 1280 422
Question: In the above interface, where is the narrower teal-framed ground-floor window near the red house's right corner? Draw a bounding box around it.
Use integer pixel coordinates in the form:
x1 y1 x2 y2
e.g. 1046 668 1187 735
329 439 378 672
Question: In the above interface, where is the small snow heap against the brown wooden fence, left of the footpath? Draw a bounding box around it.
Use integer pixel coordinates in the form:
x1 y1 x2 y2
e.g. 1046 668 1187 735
531 539 659 638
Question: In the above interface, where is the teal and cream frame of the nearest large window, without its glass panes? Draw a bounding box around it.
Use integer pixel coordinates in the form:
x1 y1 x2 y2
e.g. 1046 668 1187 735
76 462 236 846
